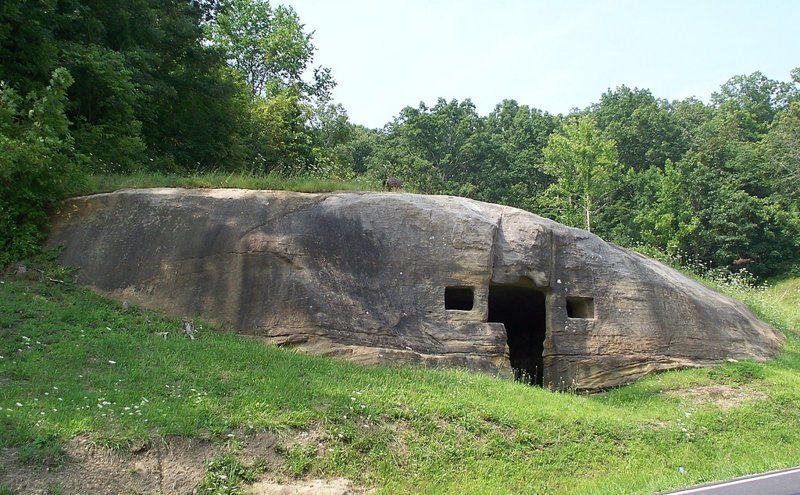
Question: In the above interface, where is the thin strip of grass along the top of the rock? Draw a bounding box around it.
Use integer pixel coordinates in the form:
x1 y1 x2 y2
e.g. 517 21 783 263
80 171 381 194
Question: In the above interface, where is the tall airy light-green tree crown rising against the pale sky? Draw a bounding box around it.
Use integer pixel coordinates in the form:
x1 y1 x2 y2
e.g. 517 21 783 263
210 0 334 100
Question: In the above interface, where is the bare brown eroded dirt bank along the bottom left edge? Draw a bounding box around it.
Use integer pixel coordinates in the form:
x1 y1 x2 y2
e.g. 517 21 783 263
0 428 365 495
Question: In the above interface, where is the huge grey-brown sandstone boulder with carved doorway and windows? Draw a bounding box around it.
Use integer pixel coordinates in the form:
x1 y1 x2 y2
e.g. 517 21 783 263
49 189 784 389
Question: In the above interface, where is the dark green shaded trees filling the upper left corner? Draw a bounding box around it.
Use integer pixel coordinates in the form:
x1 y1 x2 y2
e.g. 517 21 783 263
0 0 246 173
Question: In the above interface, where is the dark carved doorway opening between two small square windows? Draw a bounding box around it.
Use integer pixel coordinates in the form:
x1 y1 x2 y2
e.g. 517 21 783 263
489 278 547 386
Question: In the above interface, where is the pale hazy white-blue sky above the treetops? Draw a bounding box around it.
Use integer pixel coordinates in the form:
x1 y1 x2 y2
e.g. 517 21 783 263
282 0 800 127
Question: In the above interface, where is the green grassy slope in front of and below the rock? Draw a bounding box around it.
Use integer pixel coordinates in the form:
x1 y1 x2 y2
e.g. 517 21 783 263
0 279 800 494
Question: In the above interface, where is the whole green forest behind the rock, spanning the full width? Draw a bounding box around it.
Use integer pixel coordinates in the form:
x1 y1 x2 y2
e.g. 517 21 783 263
0 0 800 278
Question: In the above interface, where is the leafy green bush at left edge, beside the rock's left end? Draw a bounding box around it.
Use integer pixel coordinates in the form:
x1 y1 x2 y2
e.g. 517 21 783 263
0 68 84 267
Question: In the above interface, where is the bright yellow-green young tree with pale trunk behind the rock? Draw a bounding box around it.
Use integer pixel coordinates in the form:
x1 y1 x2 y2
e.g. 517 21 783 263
544 115 622 232
